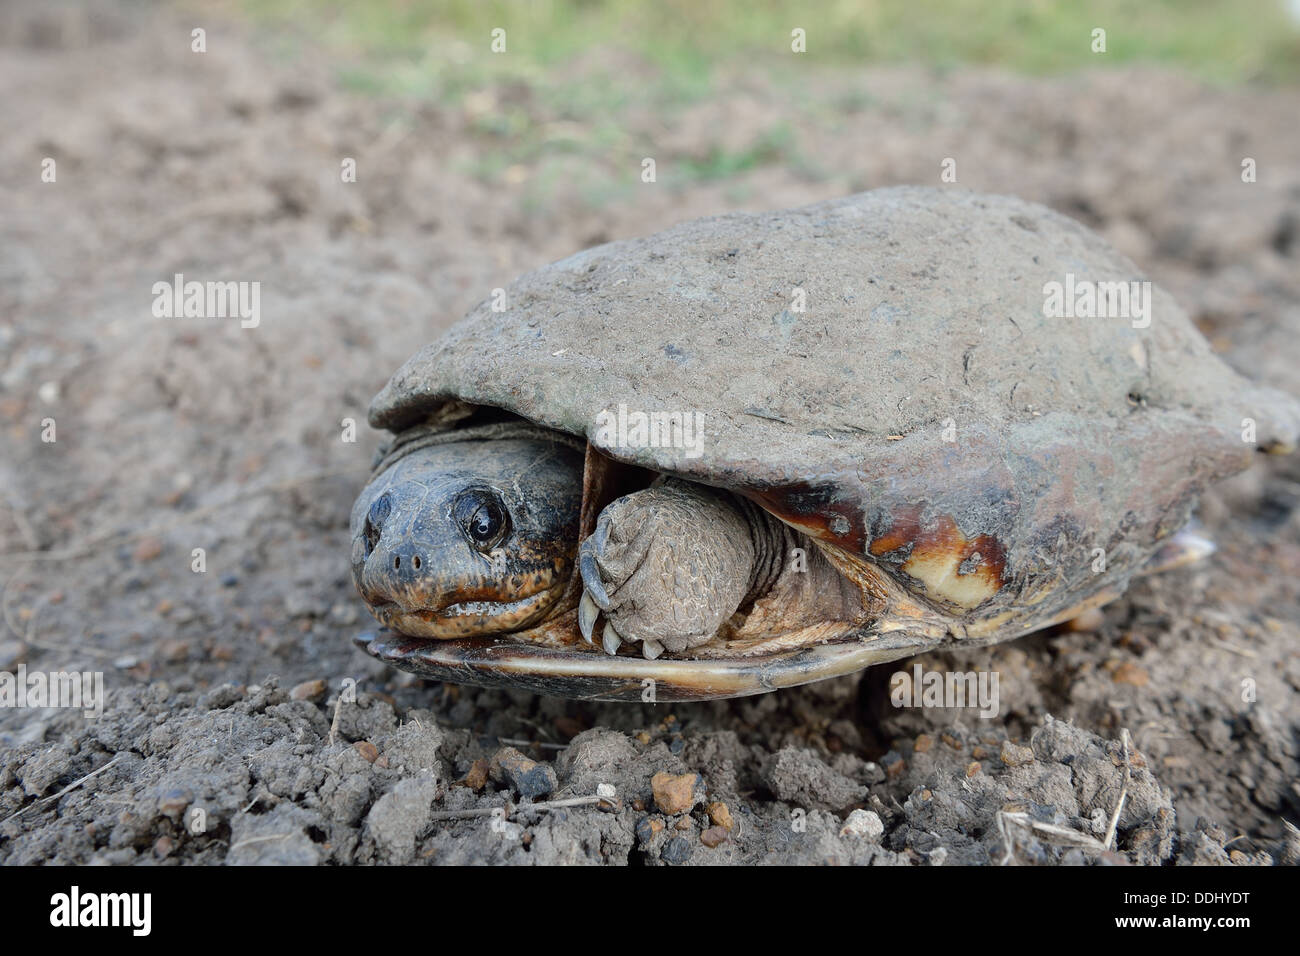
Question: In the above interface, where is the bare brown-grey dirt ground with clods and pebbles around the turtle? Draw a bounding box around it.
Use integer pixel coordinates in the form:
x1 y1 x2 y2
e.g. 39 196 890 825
0 3 1300 865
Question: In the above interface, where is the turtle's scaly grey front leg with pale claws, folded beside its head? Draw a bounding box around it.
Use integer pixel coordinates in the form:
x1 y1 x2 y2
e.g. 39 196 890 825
579 479 787 658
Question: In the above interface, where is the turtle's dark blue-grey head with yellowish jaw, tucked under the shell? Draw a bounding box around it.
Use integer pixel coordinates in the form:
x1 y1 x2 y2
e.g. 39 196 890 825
351 438 582 637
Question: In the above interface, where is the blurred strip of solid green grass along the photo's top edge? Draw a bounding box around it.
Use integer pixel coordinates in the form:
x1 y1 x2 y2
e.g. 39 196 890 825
244 0 1300 84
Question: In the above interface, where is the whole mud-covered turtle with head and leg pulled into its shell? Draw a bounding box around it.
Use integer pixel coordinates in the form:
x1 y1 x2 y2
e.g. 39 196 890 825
350 186 1300 701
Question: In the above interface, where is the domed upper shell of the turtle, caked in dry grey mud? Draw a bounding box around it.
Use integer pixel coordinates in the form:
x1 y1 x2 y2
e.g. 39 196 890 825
371 187 1300 697
